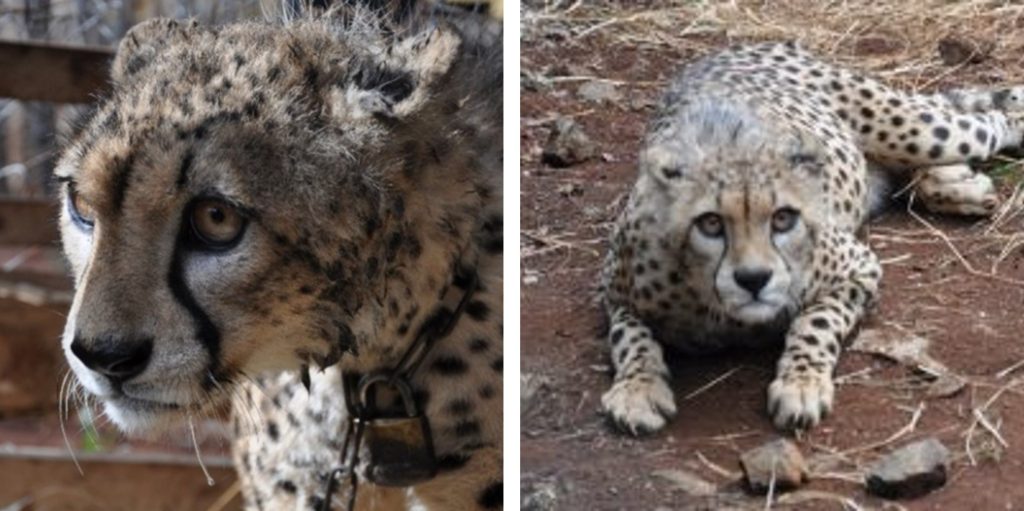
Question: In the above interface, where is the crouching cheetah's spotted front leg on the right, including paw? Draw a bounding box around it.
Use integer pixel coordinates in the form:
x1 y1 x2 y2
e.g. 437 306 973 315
768 231 882 429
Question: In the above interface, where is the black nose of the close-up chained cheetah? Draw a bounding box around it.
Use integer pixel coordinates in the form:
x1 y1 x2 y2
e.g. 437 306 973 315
71 336 153 383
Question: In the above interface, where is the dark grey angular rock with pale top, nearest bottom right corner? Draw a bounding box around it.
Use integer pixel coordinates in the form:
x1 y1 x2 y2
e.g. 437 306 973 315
866 437 949 499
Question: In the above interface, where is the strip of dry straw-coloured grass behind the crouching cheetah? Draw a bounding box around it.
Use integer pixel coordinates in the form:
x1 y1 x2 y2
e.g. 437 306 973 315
522 0 1024 90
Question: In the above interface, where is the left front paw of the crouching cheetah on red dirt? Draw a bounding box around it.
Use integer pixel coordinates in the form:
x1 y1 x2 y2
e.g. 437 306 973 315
601 374 676 435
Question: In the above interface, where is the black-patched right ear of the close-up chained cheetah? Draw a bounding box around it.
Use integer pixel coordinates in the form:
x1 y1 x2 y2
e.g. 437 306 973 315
332 27 462 120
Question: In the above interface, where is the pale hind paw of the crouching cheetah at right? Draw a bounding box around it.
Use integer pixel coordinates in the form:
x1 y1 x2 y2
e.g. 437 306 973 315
916 165 999 216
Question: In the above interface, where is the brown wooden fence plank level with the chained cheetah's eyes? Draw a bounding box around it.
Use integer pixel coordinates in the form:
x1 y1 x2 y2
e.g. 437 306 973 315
0 199 60 245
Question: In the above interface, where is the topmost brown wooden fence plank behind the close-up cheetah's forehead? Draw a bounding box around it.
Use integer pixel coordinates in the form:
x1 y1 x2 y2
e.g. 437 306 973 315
0 41 114 102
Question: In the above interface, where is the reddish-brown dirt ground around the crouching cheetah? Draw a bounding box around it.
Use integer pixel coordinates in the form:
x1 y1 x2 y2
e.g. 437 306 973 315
520 2 1024 510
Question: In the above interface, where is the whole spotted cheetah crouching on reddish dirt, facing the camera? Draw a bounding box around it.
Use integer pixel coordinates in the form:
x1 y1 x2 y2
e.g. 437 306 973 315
601 43 1024 434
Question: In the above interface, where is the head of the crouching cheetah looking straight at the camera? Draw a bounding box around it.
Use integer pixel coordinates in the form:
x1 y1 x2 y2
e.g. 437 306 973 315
640 104 823 325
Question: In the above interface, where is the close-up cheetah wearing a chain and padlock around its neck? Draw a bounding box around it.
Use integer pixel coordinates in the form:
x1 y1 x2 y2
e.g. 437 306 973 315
54 5 503 510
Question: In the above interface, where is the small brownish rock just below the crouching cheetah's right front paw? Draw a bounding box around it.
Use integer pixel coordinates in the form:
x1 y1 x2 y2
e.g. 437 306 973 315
739 438 807 494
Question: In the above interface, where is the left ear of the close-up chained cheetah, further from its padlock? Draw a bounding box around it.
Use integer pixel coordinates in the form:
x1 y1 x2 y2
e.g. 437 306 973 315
111 17 200 83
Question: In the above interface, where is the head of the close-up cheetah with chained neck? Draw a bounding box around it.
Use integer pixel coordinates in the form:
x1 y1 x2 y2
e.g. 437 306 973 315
55 11 500 430
